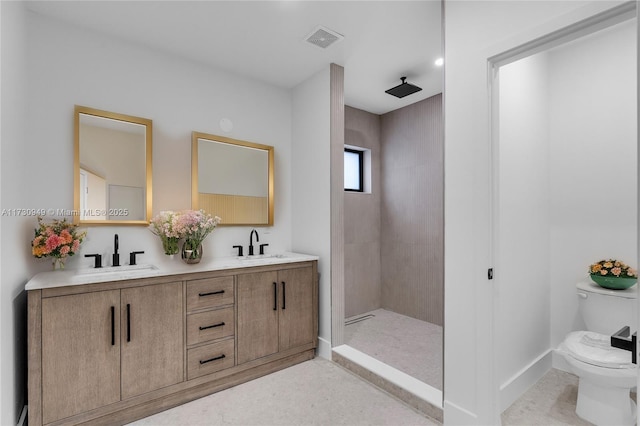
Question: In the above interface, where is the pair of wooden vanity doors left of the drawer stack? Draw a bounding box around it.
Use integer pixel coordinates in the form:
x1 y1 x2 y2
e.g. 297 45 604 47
37 282 184 424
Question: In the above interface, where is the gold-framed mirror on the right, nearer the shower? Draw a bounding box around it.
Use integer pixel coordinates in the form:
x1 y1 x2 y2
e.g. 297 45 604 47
191 132 274 226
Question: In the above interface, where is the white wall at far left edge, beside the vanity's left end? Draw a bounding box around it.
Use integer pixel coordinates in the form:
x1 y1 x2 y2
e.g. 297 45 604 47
0 2 29 425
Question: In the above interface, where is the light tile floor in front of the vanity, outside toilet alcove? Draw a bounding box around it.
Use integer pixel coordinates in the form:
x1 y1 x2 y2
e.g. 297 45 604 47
131 358 439 426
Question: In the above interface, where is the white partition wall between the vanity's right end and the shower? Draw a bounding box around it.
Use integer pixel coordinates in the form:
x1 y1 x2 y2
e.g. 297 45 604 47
291 67 331 358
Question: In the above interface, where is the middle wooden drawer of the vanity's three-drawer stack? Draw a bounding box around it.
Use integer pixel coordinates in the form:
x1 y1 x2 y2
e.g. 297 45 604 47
187 306 235 345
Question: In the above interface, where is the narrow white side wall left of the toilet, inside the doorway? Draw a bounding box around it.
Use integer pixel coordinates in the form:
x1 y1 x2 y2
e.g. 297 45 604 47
495 54 551 409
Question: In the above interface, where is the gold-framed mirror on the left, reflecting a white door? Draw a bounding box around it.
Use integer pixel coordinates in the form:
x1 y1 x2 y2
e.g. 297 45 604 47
73 105 152 225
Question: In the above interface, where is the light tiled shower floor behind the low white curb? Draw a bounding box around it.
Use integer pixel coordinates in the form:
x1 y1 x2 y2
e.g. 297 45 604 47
344 309 442 390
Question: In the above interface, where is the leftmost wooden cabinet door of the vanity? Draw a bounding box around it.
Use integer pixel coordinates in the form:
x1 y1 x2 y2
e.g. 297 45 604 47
42 290 120 424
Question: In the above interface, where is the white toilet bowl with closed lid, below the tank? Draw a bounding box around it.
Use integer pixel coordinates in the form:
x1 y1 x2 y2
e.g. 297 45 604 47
558 331 637 425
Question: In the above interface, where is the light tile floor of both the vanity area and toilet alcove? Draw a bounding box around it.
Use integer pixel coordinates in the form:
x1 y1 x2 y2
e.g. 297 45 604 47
131 358 635 426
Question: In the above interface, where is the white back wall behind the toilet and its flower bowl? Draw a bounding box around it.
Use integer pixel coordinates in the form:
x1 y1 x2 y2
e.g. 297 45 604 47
549 20 638 347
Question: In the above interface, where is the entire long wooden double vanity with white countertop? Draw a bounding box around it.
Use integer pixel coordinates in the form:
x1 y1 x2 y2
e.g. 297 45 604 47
26 253 318 426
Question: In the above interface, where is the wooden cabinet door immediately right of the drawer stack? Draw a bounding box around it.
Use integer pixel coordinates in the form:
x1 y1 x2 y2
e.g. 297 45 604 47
238 271 278 364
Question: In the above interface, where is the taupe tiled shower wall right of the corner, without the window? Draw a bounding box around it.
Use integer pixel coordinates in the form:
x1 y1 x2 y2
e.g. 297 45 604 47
380 95 444 325
